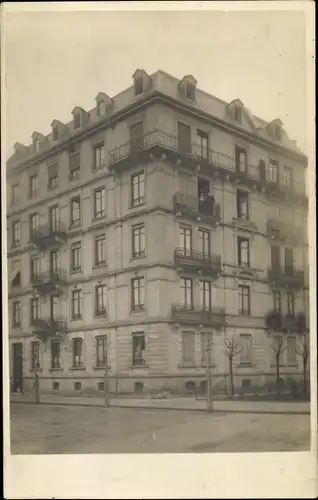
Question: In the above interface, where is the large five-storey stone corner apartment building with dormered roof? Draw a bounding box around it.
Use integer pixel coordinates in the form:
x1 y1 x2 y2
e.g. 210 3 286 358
7 70 309 393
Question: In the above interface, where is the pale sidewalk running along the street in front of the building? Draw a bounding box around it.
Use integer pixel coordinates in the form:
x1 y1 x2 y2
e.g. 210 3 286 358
10 394 310 415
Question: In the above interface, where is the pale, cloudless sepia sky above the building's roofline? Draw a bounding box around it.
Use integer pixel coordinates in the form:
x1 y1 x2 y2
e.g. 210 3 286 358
5 6 308 156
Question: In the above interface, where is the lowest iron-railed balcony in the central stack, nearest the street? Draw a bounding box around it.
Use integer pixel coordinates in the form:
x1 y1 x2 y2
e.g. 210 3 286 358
171 304 225 327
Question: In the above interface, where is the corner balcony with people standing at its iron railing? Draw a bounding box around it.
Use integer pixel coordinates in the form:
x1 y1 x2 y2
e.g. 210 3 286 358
173 193 221 227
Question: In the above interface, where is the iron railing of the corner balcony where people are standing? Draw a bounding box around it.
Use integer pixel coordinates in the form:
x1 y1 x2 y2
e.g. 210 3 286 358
173 192 221 220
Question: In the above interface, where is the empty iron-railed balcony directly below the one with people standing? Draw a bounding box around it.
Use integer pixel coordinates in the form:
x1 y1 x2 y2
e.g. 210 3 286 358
174 248 222 274
